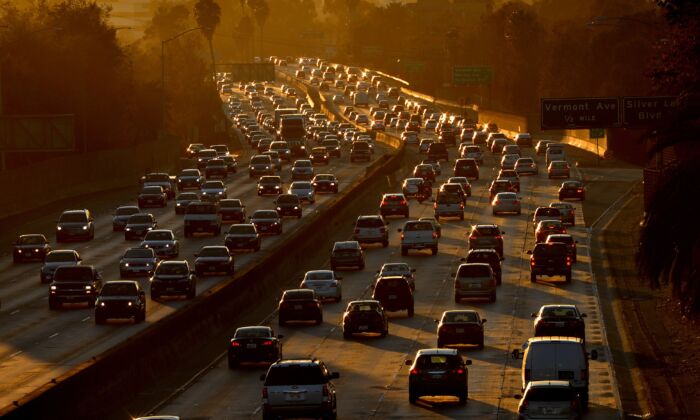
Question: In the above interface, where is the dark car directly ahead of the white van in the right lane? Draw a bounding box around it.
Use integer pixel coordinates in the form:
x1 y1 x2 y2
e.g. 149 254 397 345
532 304 587 342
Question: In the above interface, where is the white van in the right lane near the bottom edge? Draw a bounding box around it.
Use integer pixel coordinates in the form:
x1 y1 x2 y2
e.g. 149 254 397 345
512 337 598 407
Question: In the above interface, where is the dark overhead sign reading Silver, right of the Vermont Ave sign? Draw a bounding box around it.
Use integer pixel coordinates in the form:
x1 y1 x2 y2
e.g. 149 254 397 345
622 96 678 127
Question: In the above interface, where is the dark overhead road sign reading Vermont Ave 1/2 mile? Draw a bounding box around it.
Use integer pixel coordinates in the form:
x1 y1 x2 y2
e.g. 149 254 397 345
540 98 620 130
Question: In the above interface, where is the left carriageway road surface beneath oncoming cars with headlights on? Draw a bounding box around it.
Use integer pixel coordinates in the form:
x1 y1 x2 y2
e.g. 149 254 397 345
0 81 392 406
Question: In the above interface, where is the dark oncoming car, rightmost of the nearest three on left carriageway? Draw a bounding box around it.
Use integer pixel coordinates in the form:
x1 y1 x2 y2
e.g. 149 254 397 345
148 260 197 300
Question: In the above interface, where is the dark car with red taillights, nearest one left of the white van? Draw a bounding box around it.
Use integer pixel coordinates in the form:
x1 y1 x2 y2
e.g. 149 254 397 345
405 349 472 405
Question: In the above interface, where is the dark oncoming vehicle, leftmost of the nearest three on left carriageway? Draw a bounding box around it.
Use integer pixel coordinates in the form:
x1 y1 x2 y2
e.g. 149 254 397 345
49 265 102 310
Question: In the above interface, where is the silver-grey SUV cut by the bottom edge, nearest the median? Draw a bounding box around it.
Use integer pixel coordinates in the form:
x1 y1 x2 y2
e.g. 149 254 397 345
260 358 340 420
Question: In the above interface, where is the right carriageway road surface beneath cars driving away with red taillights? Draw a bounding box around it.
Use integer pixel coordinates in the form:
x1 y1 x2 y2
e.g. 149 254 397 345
152 74 620 419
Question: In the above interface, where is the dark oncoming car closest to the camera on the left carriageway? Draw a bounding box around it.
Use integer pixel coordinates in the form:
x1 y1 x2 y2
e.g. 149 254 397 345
95 280 146 325
